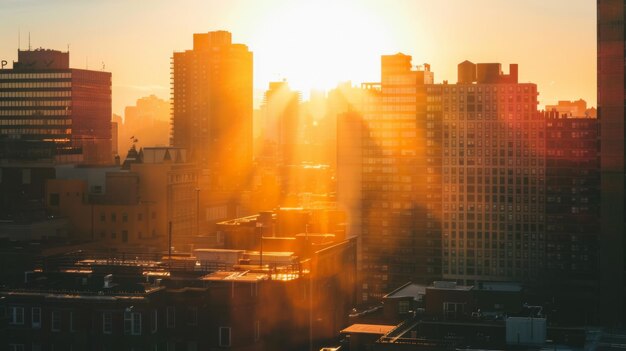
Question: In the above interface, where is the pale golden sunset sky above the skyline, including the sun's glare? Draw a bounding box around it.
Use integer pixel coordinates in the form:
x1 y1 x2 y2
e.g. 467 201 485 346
0 0 596 114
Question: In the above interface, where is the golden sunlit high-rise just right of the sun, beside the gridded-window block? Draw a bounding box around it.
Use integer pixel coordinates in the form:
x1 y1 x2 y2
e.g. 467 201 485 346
352 54 441 301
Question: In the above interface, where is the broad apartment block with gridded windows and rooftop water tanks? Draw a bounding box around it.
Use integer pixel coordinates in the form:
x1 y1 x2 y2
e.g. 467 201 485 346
426 61 545 283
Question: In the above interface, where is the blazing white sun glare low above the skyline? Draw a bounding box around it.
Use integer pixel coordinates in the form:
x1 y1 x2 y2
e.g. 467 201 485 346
247 1 389 92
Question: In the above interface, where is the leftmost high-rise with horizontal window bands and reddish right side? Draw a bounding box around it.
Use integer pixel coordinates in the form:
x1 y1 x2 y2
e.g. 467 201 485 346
0 49 112 164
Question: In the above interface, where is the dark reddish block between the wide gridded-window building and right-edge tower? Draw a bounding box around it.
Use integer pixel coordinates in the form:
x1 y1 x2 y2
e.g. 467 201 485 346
540 111 600 324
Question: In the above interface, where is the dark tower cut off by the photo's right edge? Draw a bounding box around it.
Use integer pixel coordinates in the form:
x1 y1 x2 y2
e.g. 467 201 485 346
597 0 626 325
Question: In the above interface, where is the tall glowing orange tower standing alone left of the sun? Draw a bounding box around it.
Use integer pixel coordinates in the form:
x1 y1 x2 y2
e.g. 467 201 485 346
171 31 252 190
